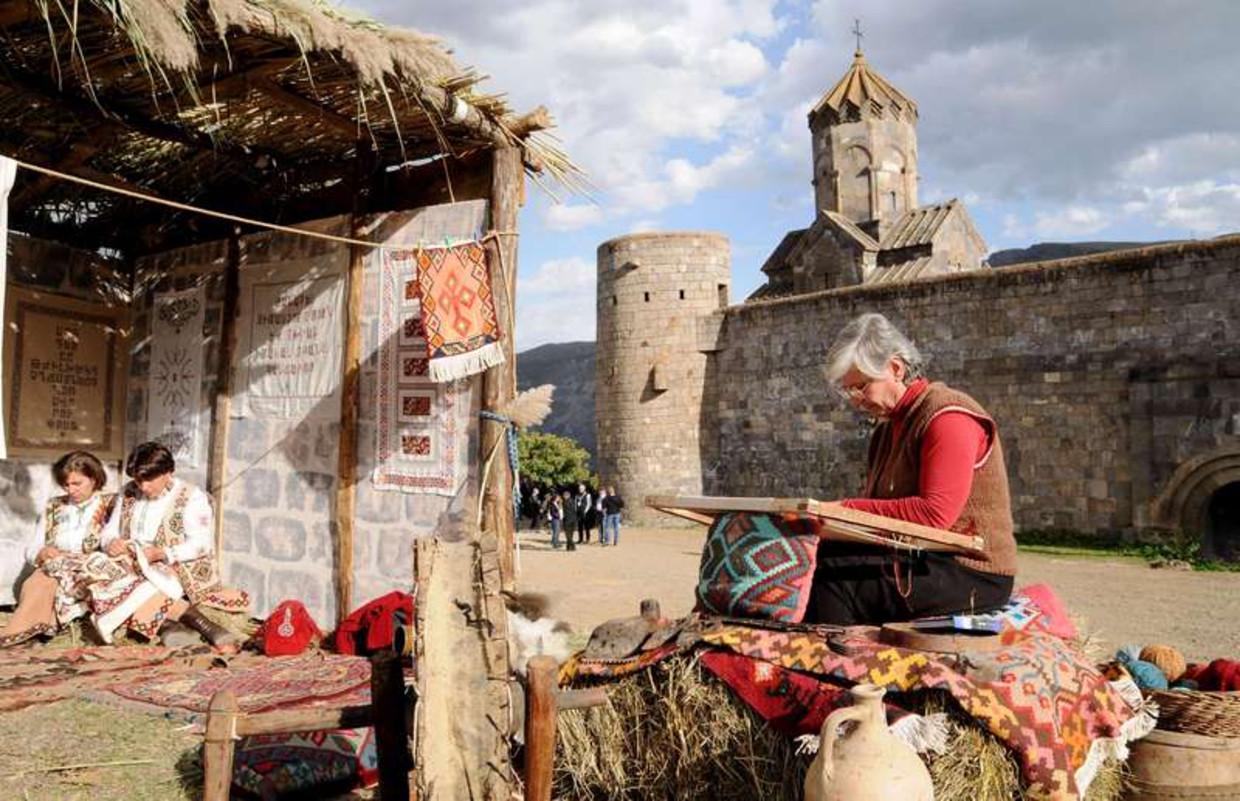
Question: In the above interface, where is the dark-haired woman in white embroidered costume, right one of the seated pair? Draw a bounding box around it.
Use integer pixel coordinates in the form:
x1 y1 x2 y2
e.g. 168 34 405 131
91 443 249 645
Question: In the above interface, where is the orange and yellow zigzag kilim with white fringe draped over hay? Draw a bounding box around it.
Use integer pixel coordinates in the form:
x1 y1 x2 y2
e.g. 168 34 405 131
702 626 1152 801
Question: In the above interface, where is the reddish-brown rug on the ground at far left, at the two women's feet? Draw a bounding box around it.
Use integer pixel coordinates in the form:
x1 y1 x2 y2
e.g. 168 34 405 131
0 645 213 712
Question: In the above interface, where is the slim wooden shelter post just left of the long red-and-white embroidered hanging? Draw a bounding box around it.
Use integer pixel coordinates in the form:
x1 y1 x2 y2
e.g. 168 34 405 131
335 141 371 622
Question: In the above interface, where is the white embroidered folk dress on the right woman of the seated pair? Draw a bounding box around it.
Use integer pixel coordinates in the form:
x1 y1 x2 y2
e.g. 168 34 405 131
91 479 249 642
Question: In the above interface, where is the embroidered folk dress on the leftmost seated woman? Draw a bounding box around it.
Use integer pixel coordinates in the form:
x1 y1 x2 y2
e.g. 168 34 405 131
0 492 117 646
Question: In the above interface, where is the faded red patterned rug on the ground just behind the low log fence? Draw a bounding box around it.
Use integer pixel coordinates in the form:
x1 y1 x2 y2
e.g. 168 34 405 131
98 653 371 722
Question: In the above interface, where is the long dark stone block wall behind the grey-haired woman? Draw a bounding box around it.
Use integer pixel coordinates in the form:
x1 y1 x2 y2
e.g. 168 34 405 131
703 237 1240 540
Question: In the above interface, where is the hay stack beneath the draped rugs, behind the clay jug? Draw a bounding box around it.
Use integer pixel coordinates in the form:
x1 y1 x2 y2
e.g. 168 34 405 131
554 657 1122 801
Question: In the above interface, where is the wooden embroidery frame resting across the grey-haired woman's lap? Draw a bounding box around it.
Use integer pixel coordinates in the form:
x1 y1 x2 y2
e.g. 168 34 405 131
646 495 985 554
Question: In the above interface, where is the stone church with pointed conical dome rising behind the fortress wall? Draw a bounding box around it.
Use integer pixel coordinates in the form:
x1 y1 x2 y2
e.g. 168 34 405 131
750 50 988 300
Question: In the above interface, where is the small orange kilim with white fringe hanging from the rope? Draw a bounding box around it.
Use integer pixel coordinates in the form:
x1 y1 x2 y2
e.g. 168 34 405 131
415 242 503 382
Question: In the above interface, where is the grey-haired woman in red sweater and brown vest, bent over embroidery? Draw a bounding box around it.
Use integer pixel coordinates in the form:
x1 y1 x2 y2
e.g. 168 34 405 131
806 314 1016 625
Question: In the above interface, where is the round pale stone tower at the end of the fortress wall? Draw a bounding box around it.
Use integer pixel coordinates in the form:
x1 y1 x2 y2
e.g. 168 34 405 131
594 232 732 520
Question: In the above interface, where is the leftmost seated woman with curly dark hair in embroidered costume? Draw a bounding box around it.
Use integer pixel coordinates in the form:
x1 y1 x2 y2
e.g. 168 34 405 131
0 450 117 647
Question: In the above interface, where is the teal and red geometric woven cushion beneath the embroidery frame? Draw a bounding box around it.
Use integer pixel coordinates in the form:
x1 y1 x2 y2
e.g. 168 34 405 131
697 512 818 622
